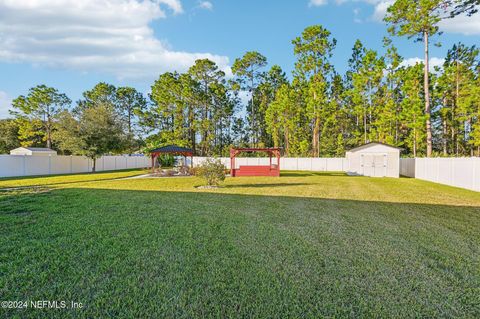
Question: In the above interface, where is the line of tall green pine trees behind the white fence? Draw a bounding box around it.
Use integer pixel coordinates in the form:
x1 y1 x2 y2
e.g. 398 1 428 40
0 0 480 158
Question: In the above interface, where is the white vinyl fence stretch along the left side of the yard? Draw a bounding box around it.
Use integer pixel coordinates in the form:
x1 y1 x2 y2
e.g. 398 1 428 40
0 155 151 177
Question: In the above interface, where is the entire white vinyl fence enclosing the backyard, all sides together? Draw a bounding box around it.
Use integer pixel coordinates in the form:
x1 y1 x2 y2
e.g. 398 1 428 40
0 155 480 191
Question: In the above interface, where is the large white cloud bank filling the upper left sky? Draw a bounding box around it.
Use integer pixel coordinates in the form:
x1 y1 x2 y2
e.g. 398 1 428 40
0 0 229 78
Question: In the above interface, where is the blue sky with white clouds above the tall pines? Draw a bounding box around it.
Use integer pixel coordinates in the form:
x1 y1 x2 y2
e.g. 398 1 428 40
0 0 480 118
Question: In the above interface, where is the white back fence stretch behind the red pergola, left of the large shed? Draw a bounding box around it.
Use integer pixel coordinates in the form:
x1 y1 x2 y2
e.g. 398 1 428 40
189 157 348 172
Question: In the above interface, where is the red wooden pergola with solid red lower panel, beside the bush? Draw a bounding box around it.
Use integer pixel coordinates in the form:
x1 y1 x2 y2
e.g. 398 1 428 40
230 148 280 177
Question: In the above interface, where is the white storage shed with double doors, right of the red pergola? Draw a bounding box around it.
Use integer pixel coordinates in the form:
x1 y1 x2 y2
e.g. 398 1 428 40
346 143 401 177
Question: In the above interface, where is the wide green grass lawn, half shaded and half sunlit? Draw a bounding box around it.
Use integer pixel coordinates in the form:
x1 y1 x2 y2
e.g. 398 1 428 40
0 171 480 318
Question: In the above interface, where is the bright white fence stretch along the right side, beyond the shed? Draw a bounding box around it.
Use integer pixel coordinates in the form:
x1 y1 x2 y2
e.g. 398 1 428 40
415 157 480 191
